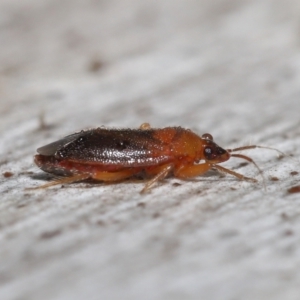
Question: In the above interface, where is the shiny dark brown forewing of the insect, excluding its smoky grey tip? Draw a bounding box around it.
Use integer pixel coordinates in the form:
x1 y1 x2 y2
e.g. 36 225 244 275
44 128 171 167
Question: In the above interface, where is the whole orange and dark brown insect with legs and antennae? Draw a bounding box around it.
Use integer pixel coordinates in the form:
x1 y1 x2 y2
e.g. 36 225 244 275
33 123 281 192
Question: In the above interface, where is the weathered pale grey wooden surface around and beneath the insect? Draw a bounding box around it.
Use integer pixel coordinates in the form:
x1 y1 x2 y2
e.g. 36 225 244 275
0 0 300 300
